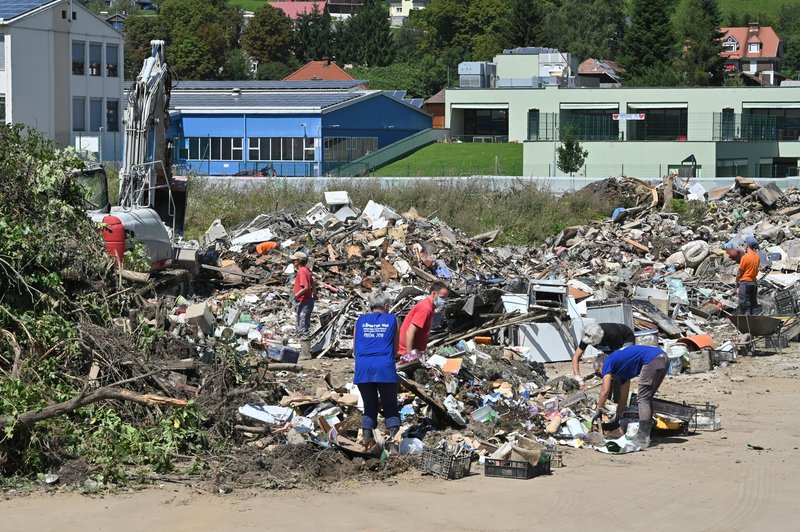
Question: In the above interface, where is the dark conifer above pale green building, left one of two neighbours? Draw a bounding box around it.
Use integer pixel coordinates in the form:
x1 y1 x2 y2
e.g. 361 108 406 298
620 0 677 80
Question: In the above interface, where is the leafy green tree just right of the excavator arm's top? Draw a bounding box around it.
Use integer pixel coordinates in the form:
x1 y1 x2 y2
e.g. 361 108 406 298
159 0 242 79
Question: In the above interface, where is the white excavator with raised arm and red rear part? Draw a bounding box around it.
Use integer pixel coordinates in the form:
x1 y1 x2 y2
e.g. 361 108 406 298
79 40 196 271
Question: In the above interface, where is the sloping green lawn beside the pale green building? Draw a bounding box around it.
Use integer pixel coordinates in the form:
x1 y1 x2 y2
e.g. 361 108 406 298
375 142 522 177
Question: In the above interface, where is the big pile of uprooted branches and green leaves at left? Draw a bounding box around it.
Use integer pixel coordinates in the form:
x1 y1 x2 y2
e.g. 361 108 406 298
0 126 209 478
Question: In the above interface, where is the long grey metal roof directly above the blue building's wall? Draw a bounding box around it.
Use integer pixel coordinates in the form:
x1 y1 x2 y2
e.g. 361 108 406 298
170 92 367 111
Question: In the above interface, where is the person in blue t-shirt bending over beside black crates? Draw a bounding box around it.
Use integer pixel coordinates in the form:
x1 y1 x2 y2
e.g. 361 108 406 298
592 345 668 449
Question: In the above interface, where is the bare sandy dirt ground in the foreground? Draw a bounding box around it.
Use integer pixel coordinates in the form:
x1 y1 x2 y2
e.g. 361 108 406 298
0 350 800 532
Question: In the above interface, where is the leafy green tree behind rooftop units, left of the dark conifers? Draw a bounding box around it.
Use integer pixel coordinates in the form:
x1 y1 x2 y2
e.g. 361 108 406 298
544 0 625 60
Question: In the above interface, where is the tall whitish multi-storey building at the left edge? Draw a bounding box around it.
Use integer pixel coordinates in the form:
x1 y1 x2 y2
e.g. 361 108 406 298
0 0 124 160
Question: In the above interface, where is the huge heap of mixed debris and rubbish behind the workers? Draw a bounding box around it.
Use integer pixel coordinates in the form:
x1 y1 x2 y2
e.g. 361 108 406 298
159 178 800 478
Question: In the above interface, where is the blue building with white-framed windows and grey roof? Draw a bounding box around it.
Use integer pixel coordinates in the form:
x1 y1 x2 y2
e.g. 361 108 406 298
170 80 432 176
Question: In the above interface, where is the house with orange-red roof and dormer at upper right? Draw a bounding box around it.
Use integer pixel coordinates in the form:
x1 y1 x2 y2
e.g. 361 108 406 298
720 23 783 86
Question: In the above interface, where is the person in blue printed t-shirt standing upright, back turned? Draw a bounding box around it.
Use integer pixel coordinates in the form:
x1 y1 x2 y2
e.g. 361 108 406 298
353 292 400 443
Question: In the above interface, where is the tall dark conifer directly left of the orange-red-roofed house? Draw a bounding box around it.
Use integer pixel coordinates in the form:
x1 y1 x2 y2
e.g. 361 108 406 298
677 0 724 87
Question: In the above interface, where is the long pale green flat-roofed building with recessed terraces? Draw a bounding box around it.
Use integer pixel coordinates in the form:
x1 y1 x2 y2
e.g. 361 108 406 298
445 64 800 178
